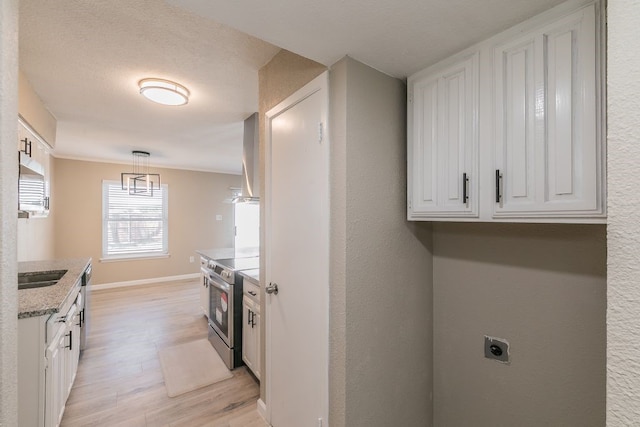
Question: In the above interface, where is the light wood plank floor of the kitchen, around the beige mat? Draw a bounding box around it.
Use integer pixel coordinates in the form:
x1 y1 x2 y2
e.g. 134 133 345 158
62 281 268 427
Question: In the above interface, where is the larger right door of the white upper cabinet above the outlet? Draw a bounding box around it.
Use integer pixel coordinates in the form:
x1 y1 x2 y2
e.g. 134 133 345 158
492 4 603 218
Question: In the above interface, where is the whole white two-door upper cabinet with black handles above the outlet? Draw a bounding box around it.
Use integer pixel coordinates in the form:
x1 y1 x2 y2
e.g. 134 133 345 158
408 1 606 223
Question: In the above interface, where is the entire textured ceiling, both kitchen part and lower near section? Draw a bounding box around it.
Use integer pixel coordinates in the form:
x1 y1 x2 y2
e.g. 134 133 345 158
19 0 561 173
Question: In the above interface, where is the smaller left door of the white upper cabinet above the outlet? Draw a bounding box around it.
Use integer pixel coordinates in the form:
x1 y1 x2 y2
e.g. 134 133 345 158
408 53 478 219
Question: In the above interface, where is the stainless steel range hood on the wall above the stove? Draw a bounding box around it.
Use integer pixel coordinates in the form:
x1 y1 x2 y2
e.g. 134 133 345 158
233 113 260 203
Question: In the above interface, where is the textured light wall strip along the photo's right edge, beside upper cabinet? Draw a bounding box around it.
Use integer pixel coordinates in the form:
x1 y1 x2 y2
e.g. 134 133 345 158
607 0 640 426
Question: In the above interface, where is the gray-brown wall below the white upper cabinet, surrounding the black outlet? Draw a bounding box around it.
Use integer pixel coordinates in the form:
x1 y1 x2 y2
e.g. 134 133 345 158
433 223 606 427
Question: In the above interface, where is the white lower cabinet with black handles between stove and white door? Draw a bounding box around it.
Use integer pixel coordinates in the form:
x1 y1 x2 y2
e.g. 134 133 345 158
242 281 260 379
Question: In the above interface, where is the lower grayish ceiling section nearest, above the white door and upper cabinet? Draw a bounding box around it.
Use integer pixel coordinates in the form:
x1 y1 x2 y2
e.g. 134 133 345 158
167 0 564 78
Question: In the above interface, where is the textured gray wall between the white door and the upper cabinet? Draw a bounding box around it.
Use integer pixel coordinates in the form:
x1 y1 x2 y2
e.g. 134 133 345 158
330 57 433 427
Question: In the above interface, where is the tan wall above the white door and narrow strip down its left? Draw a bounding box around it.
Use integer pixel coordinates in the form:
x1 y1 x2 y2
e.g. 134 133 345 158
258 50 327 400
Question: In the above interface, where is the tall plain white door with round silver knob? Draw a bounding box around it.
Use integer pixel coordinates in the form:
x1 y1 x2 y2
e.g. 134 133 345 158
265 73 329 427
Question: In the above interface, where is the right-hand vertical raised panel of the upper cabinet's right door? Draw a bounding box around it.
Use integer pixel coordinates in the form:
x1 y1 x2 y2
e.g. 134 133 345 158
544 5 598 210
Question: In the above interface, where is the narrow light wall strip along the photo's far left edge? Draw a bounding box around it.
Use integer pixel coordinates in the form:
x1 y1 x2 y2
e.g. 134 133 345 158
0 0 18 426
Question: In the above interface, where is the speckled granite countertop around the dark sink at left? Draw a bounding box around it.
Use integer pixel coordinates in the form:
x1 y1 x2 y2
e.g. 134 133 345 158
16 258 91 319
